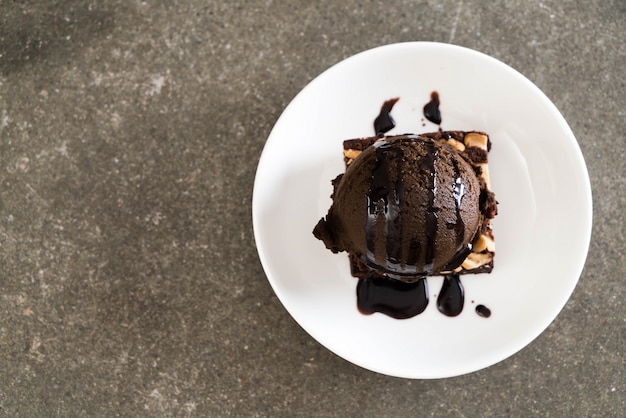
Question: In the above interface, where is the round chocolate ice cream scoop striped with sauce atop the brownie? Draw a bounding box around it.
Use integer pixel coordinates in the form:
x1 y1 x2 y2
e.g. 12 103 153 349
314 135 483 281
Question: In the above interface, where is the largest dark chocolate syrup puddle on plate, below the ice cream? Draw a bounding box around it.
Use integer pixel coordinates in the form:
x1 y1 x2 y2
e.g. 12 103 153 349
357 278 428 319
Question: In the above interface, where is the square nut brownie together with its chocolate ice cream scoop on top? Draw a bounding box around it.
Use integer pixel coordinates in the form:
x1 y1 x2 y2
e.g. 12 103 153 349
313 131 497 318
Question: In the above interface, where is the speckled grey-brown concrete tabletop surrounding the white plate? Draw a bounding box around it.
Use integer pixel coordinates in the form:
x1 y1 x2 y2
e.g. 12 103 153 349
0 0 626 417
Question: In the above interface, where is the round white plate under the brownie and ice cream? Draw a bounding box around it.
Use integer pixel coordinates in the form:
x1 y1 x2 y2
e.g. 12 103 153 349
252 42 592 378
